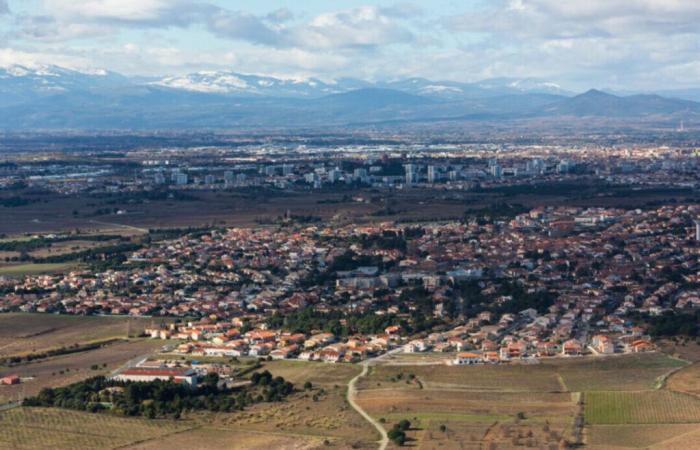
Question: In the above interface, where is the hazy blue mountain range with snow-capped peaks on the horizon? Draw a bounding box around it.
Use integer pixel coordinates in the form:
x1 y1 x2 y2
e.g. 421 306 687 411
0 66 700 130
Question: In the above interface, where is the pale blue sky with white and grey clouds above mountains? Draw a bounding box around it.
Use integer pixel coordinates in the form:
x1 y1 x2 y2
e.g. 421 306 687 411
0 0 700 90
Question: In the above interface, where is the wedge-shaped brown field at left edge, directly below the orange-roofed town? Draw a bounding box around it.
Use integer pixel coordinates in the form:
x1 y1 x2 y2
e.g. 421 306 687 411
0 313 161 358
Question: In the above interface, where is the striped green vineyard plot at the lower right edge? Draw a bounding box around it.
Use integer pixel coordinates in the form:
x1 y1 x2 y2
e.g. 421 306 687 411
584 390 700 425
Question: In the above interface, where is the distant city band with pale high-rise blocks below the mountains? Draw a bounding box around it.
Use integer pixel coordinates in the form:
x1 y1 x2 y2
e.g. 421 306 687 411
0 144 700 195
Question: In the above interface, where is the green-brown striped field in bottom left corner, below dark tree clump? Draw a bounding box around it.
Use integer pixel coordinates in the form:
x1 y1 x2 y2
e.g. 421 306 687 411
0 408 192 450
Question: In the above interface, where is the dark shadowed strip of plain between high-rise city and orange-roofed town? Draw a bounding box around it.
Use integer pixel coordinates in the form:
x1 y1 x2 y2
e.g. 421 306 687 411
0 182 695 234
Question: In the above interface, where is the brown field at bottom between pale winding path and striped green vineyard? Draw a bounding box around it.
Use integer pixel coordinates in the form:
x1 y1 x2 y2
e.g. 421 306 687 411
359 389 575 449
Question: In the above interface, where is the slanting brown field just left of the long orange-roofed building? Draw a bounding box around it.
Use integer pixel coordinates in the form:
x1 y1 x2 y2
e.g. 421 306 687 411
0 339 163 403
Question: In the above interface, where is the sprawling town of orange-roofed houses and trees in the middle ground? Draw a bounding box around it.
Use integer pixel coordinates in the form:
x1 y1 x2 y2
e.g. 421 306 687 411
0 200 700 362
